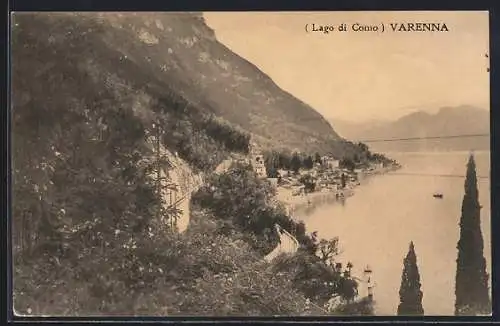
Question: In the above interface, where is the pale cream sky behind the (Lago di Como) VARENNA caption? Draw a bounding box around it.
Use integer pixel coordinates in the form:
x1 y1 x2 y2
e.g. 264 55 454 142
204 11 489 122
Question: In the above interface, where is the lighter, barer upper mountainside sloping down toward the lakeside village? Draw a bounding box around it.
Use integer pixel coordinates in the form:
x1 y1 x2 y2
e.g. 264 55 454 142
11 13 339 155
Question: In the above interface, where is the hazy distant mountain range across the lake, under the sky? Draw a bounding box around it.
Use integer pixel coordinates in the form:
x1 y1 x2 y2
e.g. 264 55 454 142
330 105 490 152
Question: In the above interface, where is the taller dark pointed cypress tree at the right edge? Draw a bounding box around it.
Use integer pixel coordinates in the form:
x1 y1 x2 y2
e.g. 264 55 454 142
455 155 491 315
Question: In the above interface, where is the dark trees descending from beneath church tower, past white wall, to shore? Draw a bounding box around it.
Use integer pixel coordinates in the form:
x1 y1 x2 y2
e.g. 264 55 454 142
193 164 358 306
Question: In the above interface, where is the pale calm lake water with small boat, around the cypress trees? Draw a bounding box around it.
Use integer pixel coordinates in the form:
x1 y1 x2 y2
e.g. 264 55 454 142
300 152 491 315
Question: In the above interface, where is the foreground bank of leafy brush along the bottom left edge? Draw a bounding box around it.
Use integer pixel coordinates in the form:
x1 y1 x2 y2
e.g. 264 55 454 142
15 211 322 316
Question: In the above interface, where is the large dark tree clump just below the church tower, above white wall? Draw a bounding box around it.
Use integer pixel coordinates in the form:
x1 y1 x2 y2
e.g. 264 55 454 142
193 163 313 254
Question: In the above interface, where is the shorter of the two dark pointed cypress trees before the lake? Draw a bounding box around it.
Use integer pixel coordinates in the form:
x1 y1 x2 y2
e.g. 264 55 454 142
398 241 424 316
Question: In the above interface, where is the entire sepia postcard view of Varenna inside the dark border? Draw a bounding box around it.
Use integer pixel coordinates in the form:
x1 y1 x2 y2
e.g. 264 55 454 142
10 11 492 318
